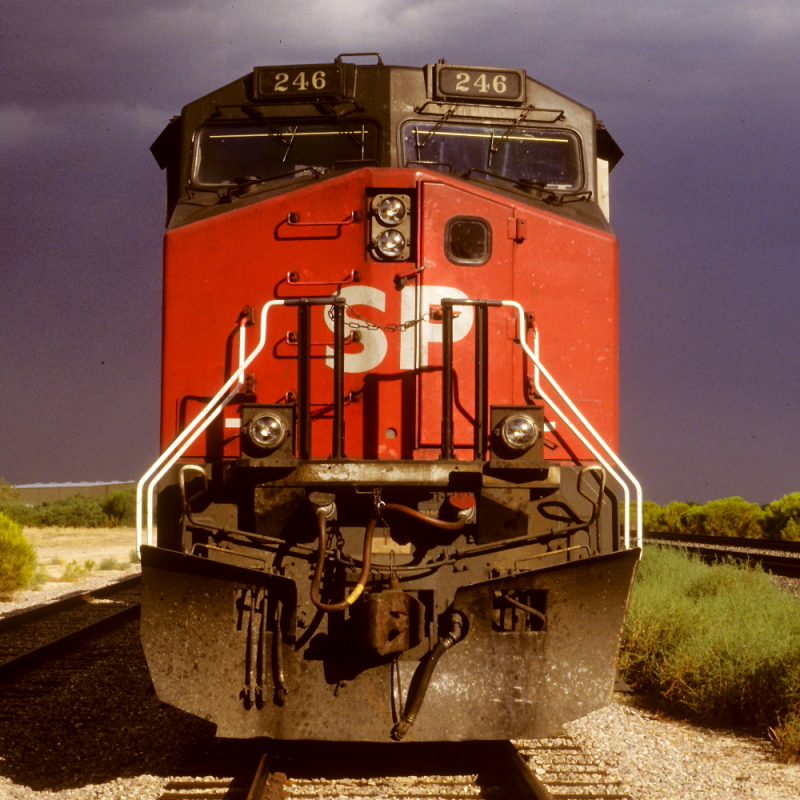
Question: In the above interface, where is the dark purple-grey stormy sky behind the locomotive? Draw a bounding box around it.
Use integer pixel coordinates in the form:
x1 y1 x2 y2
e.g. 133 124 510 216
0 0 800 503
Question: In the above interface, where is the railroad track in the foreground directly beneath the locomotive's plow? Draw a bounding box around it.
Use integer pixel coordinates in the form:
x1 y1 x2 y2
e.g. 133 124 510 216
159 737 632 800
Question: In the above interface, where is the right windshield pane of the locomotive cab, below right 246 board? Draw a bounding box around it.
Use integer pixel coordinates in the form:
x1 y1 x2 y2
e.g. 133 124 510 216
403 121 581 189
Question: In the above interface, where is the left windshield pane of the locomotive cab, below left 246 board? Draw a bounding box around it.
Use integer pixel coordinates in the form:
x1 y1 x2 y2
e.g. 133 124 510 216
192 120 378 186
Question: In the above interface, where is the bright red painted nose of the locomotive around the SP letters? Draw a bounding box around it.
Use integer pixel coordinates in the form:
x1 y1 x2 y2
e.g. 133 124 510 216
161 169 617 459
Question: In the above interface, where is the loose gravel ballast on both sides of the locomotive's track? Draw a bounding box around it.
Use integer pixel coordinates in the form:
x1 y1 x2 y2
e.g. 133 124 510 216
0 564 800 800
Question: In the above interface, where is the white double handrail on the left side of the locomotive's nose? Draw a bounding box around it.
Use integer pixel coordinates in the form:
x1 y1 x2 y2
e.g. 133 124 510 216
136 300 285 550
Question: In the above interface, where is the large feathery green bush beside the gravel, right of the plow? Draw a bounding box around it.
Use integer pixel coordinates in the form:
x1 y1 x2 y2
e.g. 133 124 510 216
620 547 800 752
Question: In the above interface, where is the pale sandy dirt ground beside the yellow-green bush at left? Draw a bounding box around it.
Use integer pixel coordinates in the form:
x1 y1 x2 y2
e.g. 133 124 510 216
0 528 139 616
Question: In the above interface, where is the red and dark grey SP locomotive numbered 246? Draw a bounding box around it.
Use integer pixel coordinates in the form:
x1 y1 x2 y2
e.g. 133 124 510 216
137 54 641 742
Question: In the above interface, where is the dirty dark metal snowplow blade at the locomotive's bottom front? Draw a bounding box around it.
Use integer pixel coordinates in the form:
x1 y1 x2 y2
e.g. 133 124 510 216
141 547 639 742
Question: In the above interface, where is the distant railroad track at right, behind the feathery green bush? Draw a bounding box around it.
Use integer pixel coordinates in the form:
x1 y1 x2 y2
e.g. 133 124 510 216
644 534 800 578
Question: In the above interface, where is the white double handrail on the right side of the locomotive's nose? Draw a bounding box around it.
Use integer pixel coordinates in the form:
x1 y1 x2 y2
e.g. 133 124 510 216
502 300 642 548
